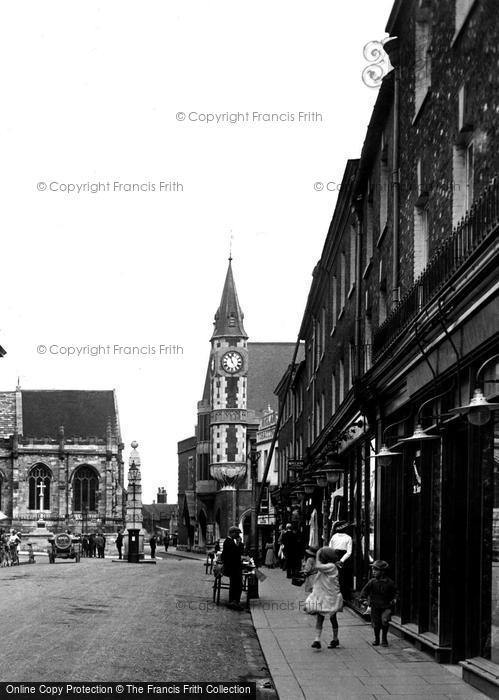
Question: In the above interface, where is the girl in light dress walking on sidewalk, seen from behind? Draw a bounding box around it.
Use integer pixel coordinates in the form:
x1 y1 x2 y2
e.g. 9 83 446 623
305 547 343 649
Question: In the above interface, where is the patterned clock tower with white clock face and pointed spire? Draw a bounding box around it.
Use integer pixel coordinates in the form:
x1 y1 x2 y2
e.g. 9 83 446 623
209 258 248 494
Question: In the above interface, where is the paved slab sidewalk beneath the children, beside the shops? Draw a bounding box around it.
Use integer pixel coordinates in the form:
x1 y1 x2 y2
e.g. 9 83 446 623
251 568 486 700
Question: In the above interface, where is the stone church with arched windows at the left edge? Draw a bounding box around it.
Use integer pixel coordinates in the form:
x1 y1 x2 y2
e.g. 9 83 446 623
0 386 124 533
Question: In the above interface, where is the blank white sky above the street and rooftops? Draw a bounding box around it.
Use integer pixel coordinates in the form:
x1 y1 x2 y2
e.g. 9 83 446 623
0 0 393 503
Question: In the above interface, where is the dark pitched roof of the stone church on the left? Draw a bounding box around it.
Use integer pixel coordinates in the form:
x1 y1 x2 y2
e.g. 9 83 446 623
21 390 121 440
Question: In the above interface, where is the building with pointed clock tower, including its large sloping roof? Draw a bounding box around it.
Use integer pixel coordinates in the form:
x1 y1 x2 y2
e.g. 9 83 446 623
179 258 294 551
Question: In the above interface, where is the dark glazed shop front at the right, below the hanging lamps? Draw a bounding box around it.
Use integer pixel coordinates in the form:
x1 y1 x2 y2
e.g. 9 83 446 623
376 370 499 697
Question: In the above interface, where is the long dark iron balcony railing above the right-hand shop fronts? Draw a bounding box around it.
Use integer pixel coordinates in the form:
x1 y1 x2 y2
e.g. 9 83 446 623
373 178 499 359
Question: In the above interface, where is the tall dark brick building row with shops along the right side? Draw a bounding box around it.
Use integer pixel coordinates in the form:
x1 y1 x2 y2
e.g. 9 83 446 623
278 0 499 692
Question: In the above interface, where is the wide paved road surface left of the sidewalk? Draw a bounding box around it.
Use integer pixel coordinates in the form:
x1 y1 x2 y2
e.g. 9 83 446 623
0 556 269 694
